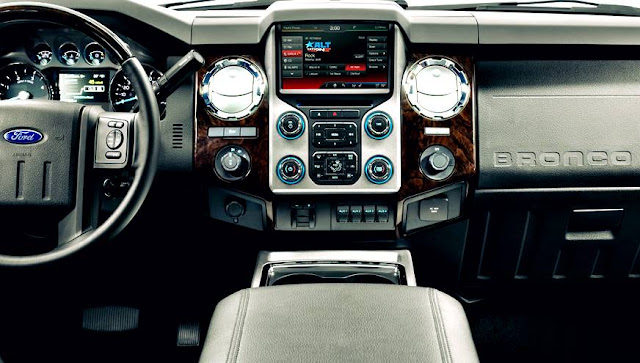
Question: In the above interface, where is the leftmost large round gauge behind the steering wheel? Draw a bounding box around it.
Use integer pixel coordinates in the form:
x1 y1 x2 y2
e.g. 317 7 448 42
0 63 53 100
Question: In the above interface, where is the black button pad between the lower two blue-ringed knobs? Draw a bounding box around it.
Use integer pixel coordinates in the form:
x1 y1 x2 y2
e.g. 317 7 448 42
311 151 358 184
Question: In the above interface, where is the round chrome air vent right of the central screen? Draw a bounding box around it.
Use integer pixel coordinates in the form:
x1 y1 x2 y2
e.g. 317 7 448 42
402 57 470 121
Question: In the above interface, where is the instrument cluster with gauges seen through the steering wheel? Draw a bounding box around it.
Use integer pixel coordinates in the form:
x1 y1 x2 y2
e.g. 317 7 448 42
0 29 164 112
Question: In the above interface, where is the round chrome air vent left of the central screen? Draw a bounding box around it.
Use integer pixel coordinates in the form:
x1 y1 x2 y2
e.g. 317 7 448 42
200 58 267 121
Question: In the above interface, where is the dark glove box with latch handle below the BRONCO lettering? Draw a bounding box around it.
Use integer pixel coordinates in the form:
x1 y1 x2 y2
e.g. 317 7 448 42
463 188 640 283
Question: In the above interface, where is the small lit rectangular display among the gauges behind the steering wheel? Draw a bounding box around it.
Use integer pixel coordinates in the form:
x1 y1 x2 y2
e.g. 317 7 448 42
58 71 109 103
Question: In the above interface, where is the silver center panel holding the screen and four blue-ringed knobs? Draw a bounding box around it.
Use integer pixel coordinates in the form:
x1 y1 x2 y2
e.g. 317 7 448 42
265 23 404 195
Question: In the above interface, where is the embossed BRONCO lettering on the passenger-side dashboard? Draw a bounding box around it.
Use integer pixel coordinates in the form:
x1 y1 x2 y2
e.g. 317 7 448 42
493 151 631 168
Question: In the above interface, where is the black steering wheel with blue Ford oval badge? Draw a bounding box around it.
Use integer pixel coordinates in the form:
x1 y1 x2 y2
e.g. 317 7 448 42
0 2 160 266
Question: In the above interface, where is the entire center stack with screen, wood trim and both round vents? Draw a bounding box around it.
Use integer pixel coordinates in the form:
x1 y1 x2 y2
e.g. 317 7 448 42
195 20 476 239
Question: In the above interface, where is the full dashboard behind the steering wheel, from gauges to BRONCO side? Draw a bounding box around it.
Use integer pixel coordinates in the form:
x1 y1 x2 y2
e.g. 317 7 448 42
0 1 640 290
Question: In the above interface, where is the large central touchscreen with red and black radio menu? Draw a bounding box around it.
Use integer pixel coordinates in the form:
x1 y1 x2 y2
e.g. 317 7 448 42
279 23 392 92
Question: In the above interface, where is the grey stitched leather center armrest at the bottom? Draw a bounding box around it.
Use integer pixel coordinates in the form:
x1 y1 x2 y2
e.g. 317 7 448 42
200 284 478 363
